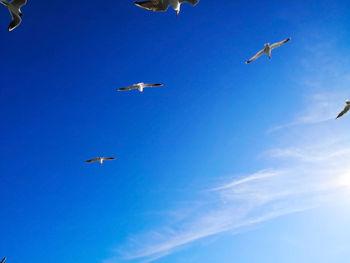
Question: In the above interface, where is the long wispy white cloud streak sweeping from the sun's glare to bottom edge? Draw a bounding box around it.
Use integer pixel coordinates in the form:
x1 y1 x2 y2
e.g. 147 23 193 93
110 137 350 262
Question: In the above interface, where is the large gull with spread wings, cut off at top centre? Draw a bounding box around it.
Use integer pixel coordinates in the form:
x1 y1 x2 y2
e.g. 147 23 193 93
134 0 199 16
